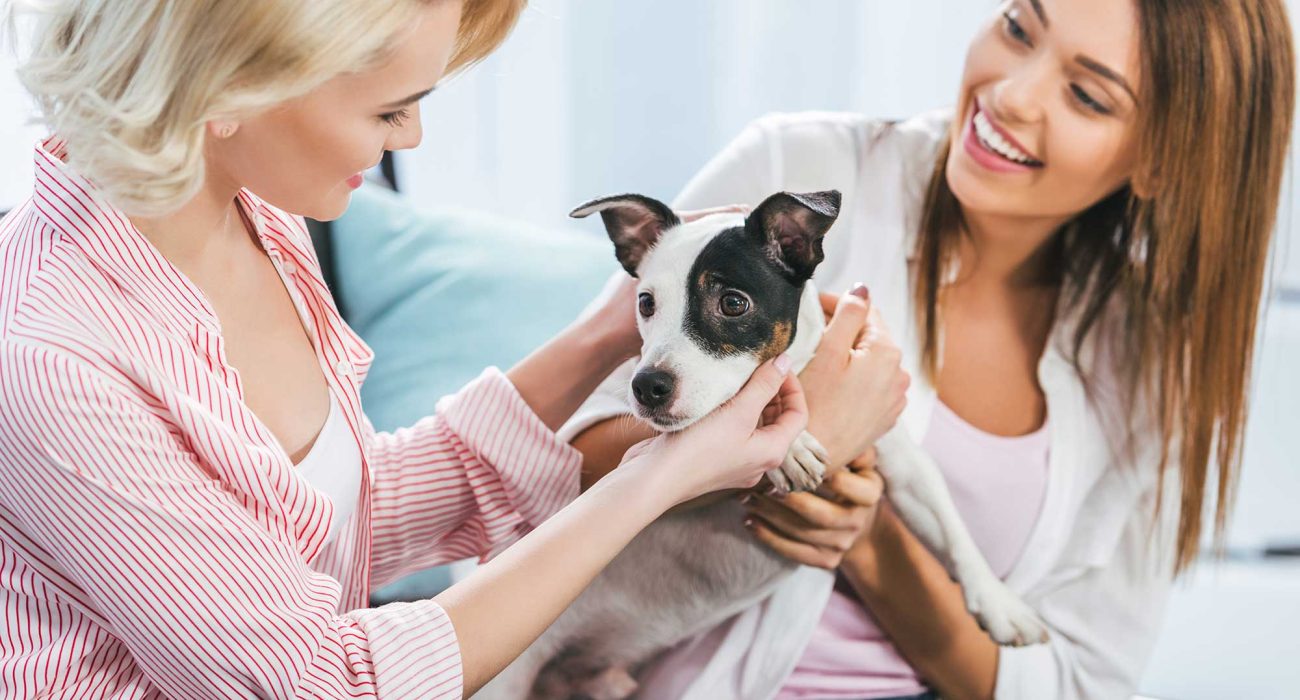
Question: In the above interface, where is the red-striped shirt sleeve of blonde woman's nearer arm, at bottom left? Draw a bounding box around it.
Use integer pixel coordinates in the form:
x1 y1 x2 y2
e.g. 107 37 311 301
0 343 463 699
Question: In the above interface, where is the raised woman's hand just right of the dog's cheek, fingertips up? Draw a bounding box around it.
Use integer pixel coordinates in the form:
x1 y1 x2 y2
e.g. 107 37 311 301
800 285 910 470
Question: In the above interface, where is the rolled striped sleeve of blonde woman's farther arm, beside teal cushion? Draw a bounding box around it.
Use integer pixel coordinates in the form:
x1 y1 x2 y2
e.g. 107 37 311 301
365 368 582 587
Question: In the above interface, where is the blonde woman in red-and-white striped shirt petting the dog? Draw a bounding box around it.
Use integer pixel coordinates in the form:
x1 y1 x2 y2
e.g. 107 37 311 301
0 0 898 699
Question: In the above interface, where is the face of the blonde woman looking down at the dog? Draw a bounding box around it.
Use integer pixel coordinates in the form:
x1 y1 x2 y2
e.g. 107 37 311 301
209 0 462 220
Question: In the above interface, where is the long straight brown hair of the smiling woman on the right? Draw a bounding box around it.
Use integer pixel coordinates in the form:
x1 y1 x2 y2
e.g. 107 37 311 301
913 0 1295 571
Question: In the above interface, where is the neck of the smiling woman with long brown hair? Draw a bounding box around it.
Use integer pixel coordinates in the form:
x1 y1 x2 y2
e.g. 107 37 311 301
957 205 1067 289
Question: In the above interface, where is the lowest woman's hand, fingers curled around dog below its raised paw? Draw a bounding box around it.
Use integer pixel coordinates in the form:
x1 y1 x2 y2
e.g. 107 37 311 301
741 448 884 570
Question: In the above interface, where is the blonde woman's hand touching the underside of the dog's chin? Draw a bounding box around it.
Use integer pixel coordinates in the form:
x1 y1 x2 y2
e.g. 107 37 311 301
616 354 807 505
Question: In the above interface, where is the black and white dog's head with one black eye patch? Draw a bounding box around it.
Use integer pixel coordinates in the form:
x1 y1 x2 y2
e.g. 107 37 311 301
571 190 840 431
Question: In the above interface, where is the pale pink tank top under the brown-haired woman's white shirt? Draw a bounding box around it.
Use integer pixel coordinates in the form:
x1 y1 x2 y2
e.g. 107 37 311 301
777 401 1049 700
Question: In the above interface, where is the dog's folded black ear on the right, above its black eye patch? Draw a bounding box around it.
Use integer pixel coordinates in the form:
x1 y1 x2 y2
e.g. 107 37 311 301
745 190 840 282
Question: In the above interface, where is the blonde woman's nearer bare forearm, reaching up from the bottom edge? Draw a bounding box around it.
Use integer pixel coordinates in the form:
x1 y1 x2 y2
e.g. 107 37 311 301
436 460 675 696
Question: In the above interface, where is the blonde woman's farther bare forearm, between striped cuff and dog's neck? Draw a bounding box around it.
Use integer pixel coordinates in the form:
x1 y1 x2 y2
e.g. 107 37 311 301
506 320 628 431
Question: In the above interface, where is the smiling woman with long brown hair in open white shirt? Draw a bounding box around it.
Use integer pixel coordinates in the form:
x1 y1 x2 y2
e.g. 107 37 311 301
575 0 1295 700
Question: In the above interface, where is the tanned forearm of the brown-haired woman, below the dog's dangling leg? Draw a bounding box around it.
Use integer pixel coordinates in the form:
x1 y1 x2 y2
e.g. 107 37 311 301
840 507 998 700
